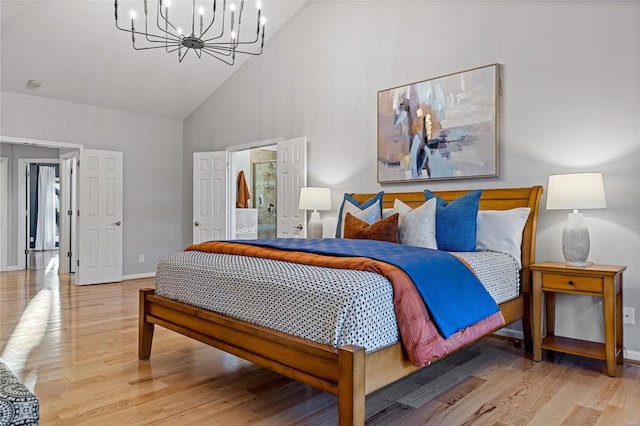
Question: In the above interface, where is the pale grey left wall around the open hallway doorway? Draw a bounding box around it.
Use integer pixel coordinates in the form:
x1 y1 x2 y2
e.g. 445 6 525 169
1 92 183 276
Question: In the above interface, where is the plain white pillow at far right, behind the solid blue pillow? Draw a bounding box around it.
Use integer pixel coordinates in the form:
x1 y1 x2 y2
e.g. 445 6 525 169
476 207 531 268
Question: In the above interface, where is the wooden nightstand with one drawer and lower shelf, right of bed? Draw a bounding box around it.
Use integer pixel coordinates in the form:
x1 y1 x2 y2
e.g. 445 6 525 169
531 262 627 377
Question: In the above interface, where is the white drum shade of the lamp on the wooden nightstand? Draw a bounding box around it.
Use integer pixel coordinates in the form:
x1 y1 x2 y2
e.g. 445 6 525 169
547 173 607 210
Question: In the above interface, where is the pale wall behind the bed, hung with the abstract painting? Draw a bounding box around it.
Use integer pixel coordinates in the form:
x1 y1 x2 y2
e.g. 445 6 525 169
183 1 640 359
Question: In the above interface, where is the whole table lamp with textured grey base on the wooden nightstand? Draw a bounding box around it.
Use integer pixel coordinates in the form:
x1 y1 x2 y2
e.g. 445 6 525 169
547 173 607 266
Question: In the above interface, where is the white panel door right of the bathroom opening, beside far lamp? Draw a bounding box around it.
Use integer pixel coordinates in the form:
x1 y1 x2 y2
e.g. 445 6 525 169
276 136 307 238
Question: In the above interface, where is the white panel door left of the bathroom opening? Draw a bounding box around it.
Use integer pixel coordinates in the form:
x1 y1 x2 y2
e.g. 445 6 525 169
193 151 229 244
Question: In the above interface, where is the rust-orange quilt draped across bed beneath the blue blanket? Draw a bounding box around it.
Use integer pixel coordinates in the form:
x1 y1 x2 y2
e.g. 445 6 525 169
186 241 504 367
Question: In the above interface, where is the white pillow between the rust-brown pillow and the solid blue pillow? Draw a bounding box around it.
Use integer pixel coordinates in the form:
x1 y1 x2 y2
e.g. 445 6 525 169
393 198 438 250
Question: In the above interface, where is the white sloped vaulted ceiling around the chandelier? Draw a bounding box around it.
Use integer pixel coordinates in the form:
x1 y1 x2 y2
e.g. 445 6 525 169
0 0 305 120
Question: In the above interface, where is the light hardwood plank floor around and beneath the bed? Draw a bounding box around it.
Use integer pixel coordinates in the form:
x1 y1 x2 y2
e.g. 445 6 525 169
0 255 640 425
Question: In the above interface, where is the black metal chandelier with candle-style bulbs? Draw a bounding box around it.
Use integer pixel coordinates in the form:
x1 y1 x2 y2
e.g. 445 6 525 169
114 0 265 65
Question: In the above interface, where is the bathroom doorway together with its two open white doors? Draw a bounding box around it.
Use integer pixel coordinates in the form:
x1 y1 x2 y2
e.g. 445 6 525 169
192 136 307 244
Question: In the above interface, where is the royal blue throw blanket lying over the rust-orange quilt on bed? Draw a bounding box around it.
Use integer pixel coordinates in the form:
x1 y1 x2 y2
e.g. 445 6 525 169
232 238 499 338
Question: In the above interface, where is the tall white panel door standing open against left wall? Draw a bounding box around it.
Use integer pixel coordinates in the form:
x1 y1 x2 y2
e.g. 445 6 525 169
76 149 123 285
